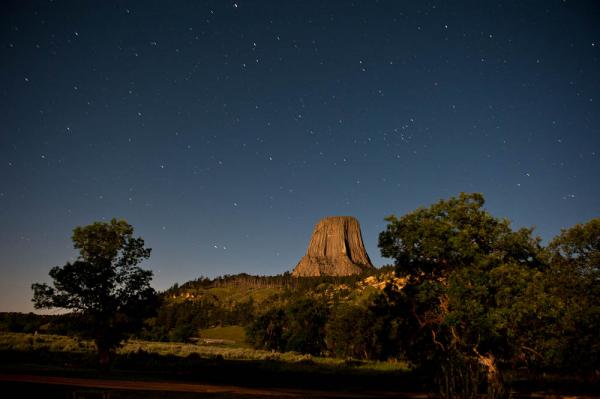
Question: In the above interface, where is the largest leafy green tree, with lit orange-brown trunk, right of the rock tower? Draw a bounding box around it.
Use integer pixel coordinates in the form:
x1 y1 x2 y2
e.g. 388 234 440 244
379 193 543 397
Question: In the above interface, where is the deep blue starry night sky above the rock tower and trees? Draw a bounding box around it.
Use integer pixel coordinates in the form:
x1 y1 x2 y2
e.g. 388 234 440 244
0 0 600 311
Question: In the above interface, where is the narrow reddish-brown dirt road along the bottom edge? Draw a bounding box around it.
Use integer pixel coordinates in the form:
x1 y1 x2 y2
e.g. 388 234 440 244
0 374 427 399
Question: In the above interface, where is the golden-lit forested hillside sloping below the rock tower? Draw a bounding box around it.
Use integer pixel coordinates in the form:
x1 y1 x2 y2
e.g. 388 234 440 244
141 267 392 341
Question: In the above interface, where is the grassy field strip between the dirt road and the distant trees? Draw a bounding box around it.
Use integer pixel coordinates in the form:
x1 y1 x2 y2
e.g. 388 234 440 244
0 328 418 397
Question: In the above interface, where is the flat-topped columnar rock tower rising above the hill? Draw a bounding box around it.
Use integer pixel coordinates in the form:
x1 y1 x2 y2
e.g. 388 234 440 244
292 216 374 277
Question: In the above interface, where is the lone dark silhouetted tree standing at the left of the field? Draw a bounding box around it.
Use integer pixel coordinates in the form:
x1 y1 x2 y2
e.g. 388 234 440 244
32 219 158 366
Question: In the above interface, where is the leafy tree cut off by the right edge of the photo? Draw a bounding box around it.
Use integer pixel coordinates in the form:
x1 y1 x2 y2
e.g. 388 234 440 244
538 218 600 375
